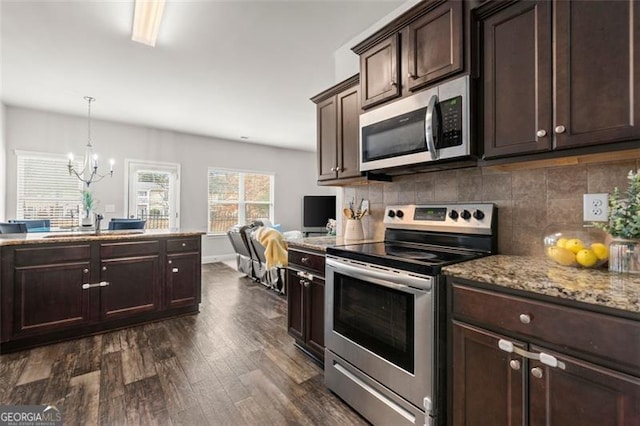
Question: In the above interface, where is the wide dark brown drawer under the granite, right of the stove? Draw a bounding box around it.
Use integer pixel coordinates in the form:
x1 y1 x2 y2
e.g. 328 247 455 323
453 283 640 370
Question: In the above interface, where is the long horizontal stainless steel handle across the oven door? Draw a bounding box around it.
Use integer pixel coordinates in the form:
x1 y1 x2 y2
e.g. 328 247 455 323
326 258 433 294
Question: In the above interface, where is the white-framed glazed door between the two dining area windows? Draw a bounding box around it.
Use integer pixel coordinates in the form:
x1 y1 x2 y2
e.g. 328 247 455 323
125 160 180 229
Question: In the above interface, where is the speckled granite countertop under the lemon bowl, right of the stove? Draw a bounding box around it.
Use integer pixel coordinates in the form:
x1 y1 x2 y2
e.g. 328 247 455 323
443 255 640 313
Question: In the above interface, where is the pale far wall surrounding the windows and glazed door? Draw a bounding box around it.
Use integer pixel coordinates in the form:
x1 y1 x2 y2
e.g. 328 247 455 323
2 106 335 260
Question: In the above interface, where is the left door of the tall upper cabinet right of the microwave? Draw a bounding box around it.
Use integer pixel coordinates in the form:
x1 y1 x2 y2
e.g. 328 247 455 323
481 1 553 158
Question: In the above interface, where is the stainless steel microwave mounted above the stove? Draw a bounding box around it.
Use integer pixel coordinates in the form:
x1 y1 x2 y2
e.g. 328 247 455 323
360 76 471 171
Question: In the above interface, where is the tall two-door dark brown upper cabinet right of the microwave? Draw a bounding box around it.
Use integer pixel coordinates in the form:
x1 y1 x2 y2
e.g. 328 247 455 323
477 0 640 159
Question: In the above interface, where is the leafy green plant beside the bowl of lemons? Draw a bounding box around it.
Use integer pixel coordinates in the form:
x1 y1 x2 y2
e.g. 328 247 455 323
594 170 640 240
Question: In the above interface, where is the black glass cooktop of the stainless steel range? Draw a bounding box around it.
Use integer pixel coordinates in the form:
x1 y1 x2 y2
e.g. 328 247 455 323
327 242 483 275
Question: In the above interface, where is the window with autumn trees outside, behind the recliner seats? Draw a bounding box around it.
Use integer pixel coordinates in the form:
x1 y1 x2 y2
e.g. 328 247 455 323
209 168 274 234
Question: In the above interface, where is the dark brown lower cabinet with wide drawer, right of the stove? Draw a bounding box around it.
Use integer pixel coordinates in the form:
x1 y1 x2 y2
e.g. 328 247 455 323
450 283 640 426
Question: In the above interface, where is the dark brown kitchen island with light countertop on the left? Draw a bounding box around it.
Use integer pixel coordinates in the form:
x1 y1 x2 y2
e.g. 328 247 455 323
0 230 203 353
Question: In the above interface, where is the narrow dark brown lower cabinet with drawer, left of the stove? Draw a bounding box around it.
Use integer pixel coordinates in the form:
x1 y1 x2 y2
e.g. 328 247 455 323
287 247 324 362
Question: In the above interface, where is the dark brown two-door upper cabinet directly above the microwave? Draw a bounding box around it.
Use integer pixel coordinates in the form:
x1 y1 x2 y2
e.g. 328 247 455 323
353 0 464 109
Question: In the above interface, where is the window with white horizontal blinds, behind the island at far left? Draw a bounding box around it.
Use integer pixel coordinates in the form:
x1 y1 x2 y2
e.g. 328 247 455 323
16 151 82 227
